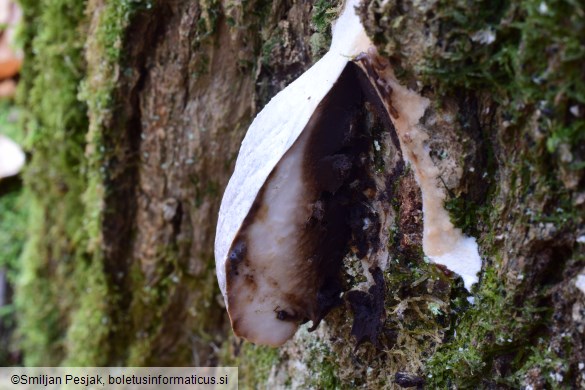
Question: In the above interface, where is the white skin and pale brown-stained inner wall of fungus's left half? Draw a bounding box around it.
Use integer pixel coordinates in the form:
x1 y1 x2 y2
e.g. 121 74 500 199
215 1 369 345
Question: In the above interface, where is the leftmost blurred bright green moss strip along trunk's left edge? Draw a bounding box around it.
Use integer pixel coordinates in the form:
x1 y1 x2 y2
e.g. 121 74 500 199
16 0 93 365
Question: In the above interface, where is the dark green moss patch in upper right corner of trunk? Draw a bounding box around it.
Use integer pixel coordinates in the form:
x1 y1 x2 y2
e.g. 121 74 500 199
421 0 585 160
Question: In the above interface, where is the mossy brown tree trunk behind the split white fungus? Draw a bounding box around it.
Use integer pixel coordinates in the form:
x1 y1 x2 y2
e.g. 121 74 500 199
10 0 585 388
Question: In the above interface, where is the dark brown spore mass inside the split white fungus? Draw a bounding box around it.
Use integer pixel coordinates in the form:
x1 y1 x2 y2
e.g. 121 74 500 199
226 58 403 344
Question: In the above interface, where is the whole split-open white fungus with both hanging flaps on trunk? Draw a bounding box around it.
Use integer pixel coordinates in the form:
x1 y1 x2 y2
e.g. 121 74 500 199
215 0 481 346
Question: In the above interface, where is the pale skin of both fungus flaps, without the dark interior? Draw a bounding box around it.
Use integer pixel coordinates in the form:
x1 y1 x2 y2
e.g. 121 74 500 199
215 0 481 346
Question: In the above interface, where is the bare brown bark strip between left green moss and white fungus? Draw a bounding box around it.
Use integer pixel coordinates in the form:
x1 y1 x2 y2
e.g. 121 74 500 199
104 2 253 365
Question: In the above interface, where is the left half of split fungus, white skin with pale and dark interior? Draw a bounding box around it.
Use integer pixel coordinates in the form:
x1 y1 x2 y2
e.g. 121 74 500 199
215 1 369 345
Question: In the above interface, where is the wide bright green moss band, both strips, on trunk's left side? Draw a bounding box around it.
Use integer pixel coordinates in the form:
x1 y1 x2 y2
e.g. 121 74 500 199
16 0 157 365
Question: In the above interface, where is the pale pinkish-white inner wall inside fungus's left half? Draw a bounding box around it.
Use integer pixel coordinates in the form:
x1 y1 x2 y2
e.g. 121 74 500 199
226 129 312 346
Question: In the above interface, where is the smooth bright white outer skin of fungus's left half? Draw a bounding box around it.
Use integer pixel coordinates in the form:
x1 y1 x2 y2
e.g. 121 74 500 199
215 0 371 298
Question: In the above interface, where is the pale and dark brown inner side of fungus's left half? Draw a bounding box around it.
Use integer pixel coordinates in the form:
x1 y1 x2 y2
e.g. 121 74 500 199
226 64 362 345
